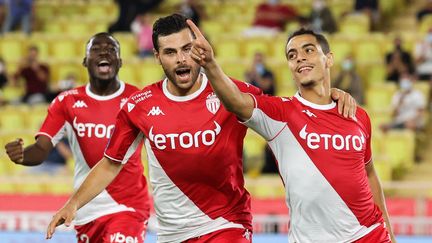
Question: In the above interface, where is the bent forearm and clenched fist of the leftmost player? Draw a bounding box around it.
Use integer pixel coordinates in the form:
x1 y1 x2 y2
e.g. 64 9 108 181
5 136 53 166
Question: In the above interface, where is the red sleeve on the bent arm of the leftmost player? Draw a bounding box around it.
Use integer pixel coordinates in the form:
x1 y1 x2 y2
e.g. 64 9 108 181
36 94 67 146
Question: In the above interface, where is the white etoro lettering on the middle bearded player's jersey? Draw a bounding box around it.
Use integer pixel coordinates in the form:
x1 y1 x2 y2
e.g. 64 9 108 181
149 121 221 150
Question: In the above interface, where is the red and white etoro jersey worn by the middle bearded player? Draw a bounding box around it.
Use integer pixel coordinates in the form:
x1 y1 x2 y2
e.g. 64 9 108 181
105 74 261 242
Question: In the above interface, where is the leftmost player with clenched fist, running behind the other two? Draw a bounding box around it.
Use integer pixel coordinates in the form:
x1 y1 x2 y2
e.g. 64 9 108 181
5 33 149 243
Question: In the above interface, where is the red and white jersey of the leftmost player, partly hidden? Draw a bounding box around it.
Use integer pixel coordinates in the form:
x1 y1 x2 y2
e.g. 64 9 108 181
37 82 149 225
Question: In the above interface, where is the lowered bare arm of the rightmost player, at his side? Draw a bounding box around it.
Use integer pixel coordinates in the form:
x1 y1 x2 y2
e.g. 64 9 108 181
366 161 396 242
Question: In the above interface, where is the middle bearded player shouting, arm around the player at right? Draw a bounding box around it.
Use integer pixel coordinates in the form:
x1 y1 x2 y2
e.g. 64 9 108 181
47 14 358 243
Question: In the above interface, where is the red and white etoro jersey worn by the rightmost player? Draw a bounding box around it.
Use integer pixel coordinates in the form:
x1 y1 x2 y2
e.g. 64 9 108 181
245 94 382 242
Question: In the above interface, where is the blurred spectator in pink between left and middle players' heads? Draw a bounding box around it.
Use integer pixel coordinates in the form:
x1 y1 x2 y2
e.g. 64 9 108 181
132 14 153 58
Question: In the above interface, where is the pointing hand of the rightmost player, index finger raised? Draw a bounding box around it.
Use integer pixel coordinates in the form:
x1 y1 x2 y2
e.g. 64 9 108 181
186 19 214 68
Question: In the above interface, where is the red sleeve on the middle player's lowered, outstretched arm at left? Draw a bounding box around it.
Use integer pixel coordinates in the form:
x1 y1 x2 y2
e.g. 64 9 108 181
105 105 143 164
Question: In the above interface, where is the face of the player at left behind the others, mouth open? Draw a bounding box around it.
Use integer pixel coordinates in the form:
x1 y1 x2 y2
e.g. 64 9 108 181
83 35 122 80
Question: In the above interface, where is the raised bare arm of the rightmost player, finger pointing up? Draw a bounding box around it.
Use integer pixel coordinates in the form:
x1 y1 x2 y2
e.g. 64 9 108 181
187 20 254 120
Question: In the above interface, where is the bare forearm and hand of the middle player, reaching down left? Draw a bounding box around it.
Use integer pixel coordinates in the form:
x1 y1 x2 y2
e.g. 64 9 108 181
46 157 123 239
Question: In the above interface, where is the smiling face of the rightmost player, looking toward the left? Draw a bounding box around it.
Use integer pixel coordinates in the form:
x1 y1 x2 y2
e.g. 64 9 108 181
286 34 333 88
